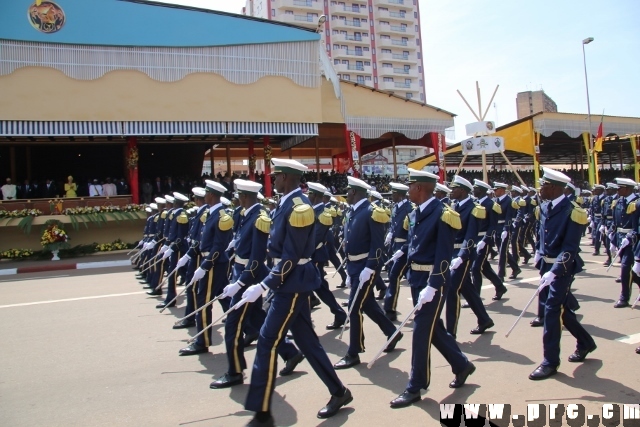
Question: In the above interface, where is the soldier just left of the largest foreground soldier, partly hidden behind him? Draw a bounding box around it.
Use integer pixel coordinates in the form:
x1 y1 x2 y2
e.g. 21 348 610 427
209 179 304 389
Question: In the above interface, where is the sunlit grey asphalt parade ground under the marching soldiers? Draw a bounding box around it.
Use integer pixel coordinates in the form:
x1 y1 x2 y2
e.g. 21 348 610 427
0 239 640 427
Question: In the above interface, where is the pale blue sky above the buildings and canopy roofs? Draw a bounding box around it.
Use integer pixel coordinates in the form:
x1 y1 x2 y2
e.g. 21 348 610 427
159 0 640 140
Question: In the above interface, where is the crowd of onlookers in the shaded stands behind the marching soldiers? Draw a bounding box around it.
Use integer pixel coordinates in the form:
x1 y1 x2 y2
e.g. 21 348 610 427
0 169 634 203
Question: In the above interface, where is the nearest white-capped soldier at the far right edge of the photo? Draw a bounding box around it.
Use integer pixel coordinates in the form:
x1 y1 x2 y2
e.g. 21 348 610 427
610 178 640 308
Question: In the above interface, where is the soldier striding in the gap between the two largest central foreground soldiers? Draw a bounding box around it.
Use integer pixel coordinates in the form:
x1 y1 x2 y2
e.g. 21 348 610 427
334 176 402 369
